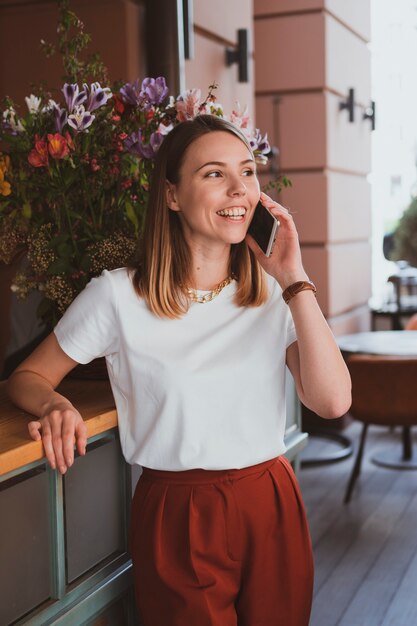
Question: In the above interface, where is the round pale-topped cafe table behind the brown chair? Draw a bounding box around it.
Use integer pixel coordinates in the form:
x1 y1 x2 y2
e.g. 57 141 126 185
336 330 417 469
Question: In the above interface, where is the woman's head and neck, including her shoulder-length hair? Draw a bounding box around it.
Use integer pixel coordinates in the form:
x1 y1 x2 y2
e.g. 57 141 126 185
134 115 267 317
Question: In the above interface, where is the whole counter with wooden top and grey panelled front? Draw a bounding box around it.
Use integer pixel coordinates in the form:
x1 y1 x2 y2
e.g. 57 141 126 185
0 379 136 626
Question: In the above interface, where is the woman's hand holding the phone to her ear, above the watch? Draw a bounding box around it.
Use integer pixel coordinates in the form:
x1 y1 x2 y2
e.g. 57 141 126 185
246 193 308 289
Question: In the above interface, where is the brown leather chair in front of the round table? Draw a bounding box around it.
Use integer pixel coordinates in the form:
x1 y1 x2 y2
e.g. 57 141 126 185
345 354 417 502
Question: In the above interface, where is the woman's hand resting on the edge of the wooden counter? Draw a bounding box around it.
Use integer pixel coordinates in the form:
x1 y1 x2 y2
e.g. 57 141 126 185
28 396 87 474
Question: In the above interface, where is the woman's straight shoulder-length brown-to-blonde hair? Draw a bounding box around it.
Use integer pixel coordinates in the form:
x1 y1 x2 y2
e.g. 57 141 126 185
131 115 268 319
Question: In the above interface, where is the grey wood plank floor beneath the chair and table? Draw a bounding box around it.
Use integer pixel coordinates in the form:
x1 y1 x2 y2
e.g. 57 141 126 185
299 422 417 626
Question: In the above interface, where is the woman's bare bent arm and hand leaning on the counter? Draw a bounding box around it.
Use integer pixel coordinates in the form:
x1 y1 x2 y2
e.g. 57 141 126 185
7 333 87 474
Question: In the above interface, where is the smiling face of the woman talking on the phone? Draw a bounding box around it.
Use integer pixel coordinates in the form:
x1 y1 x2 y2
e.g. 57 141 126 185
167 131 260 247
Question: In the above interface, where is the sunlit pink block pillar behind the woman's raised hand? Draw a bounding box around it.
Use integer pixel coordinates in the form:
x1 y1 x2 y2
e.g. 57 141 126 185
254 0 371 333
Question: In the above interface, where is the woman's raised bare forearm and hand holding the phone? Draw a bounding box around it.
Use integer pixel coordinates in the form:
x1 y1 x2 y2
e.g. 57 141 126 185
248 194 351 418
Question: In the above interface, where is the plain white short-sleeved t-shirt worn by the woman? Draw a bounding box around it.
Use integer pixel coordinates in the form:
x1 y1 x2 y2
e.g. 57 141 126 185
54 268 296 471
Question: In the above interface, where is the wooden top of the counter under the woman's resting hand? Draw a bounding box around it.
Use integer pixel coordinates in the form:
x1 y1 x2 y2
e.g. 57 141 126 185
0 379 117 476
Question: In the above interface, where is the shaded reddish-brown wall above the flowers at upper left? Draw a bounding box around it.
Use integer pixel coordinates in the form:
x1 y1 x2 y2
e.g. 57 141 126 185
0 0 145 104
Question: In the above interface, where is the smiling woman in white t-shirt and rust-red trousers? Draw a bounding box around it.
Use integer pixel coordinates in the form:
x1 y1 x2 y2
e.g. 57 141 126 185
9 115 350 626
